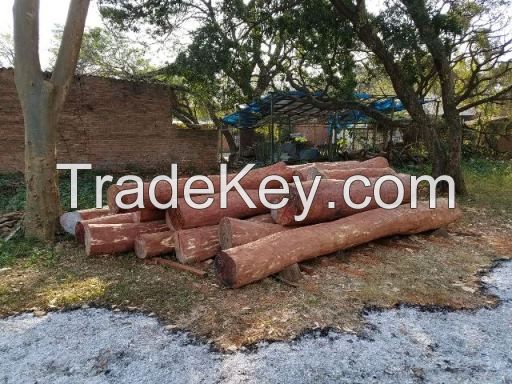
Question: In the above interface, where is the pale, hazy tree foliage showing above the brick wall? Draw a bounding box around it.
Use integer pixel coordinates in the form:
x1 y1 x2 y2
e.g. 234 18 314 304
50 27 154 79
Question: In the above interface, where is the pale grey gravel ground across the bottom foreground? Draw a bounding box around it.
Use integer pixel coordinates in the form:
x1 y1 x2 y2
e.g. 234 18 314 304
0 262 512 383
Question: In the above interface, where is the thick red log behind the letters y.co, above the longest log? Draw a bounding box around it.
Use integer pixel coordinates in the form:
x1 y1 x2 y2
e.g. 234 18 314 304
272 174 411 226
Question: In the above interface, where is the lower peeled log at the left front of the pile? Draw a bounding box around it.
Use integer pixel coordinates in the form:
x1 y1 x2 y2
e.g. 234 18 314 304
84 221 169 256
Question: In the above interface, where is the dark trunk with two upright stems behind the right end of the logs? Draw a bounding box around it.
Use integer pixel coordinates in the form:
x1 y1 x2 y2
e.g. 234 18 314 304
331 0 466 194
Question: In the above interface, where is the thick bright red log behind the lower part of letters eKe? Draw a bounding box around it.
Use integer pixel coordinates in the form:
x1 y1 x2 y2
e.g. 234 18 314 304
166 190 282 230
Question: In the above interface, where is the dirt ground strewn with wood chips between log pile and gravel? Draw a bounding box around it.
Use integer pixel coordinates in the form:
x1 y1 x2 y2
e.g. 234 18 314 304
0 204 512 350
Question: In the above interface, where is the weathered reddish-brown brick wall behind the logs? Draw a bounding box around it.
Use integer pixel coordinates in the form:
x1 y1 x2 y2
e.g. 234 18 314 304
0 69 218 172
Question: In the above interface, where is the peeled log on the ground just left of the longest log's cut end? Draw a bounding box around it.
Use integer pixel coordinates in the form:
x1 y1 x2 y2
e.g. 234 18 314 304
175 215 276 264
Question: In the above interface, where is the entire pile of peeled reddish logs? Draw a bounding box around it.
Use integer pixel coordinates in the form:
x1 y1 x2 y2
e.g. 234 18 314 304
61 157 461 288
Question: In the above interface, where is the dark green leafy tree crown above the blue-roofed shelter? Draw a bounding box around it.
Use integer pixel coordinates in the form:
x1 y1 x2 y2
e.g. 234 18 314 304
101 0 360 159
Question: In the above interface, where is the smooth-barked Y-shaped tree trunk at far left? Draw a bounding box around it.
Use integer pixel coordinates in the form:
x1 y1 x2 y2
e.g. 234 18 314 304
13 0 89 241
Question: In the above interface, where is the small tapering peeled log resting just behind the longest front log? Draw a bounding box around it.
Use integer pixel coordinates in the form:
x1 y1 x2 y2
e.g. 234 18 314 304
219 217 288 249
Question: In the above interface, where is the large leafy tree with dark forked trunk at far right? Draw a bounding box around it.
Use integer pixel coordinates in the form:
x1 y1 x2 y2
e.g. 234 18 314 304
331 0 512 193
